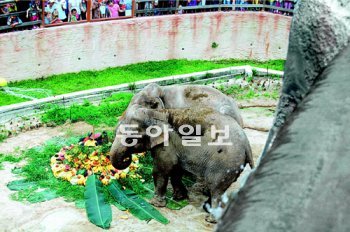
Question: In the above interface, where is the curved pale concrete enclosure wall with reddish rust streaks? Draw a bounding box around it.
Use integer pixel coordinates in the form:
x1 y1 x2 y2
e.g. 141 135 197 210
0 12 291 81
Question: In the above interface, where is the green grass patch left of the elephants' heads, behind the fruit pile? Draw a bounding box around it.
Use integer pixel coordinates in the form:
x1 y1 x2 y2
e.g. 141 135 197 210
41 93 133 126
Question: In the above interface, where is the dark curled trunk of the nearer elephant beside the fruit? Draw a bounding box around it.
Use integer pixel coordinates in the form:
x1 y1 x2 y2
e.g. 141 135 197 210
110 141 132 170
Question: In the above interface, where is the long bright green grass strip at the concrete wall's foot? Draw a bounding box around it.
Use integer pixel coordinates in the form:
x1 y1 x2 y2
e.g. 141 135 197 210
0 59 285 106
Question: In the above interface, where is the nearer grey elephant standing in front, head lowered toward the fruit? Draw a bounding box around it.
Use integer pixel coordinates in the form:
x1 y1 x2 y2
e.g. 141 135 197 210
110 104 254 218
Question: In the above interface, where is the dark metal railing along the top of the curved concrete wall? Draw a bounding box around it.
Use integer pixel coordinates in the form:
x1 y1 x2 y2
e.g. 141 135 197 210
0 0 293 33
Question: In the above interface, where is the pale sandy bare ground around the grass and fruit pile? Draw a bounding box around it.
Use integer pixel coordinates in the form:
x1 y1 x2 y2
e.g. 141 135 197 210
0 108 273 232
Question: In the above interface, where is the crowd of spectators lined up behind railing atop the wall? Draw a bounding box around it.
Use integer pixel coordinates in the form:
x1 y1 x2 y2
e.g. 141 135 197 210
0 0 298 32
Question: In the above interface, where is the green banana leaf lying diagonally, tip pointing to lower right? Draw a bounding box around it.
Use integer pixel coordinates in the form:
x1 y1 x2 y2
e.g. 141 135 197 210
108 180 169 224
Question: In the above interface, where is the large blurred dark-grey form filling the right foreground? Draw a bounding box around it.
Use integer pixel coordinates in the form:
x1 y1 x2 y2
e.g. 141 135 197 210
217 0 350 232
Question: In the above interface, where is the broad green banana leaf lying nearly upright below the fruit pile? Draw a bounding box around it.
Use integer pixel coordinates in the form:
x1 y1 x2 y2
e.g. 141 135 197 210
84 175 112 229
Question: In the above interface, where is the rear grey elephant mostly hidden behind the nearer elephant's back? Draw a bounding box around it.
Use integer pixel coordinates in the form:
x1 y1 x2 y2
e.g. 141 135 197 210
126 83 243 127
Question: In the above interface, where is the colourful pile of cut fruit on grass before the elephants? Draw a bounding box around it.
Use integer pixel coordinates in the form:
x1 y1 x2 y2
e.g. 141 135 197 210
51 134 144 185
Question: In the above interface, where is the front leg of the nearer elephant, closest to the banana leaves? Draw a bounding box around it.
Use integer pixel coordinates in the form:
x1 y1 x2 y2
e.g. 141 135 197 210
150 171 169 207
